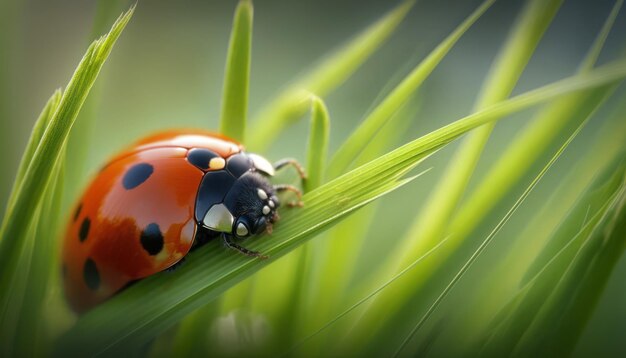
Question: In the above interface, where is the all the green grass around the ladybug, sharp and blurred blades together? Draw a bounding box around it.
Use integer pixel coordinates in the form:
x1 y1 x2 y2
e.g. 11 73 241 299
0 0 626 357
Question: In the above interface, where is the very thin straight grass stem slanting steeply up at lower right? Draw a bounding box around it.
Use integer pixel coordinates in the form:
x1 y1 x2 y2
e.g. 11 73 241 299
394 100 590 357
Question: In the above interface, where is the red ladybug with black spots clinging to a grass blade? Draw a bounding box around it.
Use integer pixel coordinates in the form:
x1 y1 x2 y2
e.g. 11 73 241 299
62 130 305 313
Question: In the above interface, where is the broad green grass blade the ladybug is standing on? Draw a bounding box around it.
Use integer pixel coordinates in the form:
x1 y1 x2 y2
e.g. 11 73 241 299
53 62 626 354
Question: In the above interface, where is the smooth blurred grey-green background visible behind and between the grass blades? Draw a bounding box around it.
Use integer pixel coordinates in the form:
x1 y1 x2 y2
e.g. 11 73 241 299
0 0 626 356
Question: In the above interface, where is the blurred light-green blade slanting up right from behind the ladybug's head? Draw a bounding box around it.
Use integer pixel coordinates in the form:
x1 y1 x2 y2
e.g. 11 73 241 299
247 0 415 152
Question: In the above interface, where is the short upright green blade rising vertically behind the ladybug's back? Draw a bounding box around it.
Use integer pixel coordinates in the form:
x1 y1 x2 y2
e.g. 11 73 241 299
220 0 253 141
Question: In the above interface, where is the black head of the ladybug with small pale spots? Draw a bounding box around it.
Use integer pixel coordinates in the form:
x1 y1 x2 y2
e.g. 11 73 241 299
225 171 280 238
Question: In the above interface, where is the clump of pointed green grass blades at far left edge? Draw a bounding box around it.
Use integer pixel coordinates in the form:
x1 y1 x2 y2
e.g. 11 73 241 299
0 8 133 354
